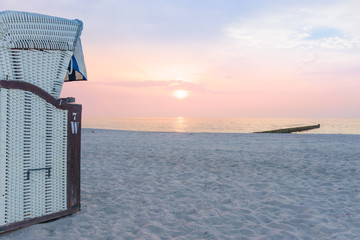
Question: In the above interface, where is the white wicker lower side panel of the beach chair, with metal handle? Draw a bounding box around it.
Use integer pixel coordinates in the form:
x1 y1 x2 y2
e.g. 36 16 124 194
0 88 68 225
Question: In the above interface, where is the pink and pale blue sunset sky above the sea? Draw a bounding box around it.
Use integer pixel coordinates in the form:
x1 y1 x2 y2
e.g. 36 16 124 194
0 0 360 118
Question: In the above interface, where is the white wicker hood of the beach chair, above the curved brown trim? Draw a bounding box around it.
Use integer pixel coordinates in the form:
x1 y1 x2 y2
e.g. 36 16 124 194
0 11 82 98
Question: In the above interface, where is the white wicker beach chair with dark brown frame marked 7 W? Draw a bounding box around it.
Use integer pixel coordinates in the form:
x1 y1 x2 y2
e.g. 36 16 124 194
0 11 86 232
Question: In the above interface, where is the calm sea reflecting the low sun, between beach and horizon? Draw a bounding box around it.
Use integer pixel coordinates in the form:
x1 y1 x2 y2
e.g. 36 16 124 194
83 117 360 134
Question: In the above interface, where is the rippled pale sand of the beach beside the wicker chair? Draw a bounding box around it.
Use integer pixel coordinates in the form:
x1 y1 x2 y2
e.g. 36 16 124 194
0 129 360 240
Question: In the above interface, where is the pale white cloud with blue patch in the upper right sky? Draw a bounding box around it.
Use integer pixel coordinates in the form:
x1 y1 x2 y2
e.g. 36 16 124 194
225 1 360 51
